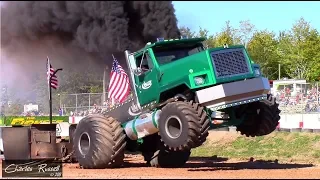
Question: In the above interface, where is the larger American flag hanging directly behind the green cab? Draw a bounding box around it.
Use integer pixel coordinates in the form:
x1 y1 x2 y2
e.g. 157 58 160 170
108 55 130 103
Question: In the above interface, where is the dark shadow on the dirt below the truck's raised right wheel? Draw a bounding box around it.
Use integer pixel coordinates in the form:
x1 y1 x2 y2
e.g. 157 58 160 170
183 156 314 171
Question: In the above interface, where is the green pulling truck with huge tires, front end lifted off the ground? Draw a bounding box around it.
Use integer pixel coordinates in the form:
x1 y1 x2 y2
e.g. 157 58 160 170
0 38 280 169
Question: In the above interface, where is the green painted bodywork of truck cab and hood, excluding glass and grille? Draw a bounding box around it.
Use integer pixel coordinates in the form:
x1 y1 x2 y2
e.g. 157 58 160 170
130 38 260 106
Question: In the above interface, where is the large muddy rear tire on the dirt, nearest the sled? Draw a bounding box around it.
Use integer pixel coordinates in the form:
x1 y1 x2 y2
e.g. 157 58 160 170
73 114 126 169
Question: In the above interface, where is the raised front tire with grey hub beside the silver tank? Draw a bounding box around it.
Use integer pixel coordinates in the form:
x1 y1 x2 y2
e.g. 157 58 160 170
158 101 210 151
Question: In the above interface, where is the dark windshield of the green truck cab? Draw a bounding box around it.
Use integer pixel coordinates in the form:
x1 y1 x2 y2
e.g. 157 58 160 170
153 43 204 65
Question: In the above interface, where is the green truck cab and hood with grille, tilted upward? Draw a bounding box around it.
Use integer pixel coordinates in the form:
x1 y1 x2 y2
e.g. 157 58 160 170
125 38 269 112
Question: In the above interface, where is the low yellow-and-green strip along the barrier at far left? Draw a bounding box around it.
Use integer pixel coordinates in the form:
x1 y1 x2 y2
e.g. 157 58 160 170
1 116 69 126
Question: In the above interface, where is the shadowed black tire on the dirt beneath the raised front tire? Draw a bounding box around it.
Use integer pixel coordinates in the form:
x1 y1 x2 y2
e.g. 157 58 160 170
141 134 191 168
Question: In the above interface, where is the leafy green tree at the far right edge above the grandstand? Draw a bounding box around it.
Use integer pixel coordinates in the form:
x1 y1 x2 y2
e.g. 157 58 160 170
279 18 320 80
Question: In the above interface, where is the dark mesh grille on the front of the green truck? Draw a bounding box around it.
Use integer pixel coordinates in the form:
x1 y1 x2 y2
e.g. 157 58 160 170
211 49 249 79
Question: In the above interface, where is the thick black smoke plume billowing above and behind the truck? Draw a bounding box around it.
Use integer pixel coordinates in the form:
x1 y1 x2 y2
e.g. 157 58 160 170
0 1 180 100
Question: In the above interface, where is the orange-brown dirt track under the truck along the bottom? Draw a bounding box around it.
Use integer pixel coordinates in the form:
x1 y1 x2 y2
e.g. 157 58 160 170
63 155 320 179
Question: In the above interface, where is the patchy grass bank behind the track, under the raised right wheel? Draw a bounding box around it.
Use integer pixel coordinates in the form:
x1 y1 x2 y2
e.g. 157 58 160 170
192 131 320 163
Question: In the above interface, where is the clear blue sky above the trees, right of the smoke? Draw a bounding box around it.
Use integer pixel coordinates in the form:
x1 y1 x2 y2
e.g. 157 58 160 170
173 1 320 33
